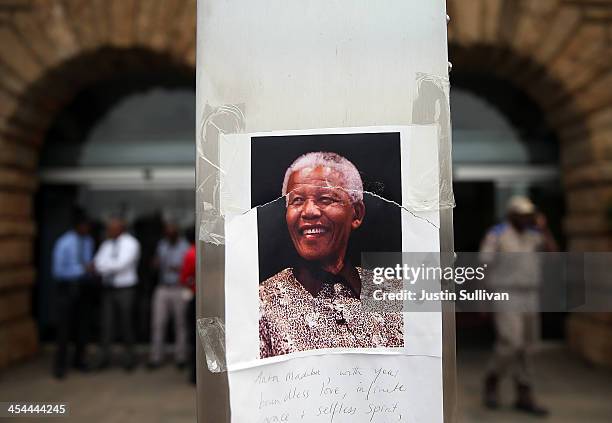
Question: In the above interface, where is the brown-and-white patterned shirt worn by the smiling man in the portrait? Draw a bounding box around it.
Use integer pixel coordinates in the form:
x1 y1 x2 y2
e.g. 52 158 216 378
259 267 404 358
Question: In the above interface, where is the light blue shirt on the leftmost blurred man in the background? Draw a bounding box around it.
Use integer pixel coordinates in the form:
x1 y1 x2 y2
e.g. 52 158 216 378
52 230 94 282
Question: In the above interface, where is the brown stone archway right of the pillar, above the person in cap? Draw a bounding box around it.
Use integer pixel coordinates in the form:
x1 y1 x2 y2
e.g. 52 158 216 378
448 0 612 367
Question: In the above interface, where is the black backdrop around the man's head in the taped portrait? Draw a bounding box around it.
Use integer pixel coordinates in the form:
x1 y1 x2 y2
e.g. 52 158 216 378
251 132 402 282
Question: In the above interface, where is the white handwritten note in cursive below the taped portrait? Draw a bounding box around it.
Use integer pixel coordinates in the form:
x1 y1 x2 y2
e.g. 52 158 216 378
230 355 442 423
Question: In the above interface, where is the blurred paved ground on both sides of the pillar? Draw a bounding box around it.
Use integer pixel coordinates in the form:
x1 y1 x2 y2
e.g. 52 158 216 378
0 346 612 423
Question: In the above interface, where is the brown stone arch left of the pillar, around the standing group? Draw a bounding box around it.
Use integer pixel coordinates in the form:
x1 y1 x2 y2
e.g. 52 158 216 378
0 0 196 368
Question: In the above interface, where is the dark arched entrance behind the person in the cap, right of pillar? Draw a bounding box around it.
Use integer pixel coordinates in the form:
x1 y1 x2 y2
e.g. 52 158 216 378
451 75 565 345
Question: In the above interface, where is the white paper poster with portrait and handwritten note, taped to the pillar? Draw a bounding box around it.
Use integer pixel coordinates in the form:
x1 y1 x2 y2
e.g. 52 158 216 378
220 125 442 422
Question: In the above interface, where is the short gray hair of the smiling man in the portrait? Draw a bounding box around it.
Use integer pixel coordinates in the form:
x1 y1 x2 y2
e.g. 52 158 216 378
282 151 363 203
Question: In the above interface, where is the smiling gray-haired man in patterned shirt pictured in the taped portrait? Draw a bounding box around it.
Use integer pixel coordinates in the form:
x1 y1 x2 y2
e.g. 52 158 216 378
253 134 404 358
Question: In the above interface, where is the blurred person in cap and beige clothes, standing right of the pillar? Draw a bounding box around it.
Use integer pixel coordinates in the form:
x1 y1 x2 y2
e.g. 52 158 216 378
480 196 558 417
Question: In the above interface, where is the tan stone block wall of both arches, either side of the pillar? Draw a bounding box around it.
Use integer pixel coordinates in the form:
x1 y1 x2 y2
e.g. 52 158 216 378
0 0 612 367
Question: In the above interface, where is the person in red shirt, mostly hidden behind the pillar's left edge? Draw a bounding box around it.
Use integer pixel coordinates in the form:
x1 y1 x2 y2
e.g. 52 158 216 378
180 227 196 383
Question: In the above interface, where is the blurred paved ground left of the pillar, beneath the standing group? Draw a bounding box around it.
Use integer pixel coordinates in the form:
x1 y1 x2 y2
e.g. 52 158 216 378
0 353 195 423
